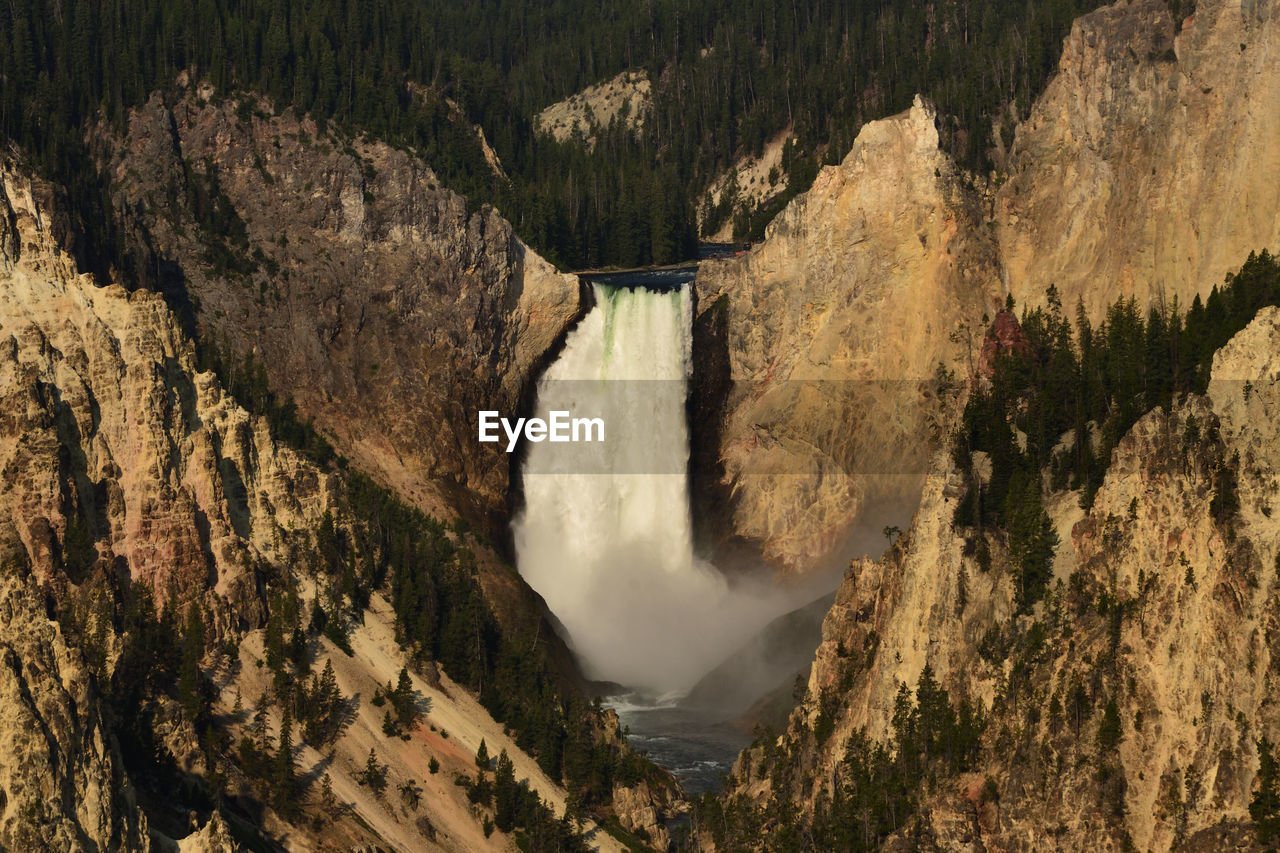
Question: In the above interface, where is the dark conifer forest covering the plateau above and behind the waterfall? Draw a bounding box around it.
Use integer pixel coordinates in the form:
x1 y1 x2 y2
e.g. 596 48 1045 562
0 0 1094 272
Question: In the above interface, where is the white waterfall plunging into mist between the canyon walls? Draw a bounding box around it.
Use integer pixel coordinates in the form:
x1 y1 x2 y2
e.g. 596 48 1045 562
515 284 781 694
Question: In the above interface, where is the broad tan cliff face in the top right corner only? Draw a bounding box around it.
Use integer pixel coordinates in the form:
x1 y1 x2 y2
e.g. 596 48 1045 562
996 0 1280 315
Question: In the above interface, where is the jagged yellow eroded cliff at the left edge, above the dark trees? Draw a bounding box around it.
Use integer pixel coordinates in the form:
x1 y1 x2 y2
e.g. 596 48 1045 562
0 165 330 612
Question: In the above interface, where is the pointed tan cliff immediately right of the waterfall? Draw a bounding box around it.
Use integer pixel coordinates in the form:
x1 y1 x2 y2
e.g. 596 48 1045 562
694 100 997 571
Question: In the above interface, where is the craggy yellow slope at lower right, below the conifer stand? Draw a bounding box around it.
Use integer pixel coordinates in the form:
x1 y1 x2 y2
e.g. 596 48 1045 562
732 307 1280 850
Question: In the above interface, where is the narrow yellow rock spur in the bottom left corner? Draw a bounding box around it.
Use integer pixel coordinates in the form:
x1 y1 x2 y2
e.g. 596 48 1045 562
0 558 151 853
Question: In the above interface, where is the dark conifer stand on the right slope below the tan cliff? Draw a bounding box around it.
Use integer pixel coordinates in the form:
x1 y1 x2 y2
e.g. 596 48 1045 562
952 250 1280 608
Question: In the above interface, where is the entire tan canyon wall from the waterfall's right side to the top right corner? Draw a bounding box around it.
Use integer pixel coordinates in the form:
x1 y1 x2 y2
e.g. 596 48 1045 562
695 0 1280 573
